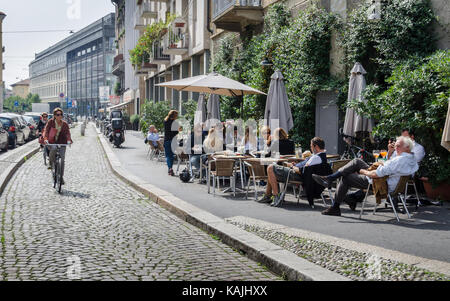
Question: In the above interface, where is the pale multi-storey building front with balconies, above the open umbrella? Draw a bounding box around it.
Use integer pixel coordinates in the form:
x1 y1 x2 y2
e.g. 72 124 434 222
112 0 212 115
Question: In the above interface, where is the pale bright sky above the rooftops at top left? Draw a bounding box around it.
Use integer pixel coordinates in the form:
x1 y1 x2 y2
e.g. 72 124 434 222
0 0 114 89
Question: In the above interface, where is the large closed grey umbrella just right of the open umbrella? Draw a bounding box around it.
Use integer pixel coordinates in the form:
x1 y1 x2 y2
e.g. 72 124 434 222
264 70 294 132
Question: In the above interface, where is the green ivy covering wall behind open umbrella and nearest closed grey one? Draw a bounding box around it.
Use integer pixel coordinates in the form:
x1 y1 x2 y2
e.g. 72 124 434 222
212 3 339 145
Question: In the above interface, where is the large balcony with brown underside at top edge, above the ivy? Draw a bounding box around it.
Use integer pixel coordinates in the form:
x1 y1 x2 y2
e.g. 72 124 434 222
212 0 264 32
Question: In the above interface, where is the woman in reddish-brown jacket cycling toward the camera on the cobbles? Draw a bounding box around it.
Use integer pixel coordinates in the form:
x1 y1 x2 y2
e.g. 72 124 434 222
43 108 73 184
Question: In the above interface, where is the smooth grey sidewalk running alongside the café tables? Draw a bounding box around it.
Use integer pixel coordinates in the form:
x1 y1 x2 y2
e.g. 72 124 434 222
114 131 450 262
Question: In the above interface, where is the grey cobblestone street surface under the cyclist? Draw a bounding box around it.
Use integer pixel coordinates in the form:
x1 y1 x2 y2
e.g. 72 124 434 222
0 125 278 280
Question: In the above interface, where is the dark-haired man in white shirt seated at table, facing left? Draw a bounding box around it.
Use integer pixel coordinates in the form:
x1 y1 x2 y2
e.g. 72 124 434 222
258 137 327 207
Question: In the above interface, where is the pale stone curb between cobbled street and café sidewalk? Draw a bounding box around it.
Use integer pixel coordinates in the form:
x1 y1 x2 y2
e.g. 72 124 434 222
91 125 350 281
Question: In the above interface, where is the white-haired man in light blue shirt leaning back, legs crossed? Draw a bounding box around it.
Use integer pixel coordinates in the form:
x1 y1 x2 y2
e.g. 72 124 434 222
313 136 419 216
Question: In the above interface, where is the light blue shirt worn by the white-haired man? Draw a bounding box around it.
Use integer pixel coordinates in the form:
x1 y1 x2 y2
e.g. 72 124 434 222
376 153 419 193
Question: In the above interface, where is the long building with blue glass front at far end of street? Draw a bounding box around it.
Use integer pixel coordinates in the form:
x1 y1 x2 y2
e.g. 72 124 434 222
30 13 116 116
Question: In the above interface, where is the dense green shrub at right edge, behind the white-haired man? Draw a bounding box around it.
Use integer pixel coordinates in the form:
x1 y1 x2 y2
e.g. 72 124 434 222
350 50 450 184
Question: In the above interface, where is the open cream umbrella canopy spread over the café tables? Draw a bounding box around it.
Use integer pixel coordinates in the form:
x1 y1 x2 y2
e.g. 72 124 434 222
156 72 265 96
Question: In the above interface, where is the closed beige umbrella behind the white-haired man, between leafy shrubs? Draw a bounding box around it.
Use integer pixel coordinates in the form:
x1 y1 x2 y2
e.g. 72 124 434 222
343 63 373 137
